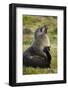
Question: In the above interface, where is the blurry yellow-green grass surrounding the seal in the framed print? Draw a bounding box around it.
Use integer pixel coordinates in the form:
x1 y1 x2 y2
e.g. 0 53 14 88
23 15 57 75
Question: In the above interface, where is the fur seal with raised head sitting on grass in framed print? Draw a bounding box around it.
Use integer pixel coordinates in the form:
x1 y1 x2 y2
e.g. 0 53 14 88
23 25 51 68
